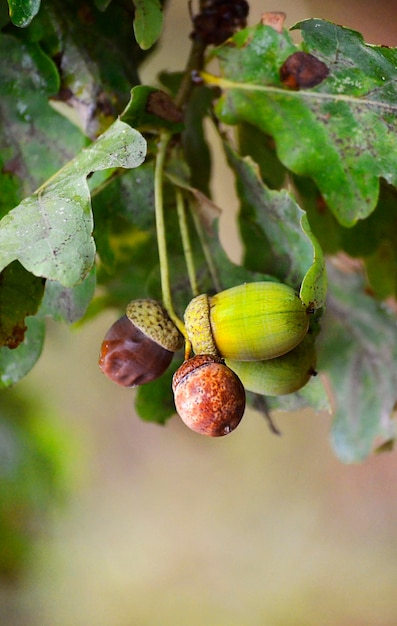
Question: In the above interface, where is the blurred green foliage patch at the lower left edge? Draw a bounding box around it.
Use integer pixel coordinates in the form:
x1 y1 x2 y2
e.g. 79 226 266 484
0 390 77 580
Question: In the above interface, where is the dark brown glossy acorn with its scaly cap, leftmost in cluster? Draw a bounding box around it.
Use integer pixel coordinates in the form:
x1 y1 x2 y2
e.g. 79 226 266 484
99 299 184 387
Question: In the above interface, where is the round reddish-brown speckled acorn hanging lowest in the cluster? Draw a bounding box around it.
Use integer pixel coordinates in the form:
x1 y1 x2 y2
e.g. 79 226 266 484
172 354 245 437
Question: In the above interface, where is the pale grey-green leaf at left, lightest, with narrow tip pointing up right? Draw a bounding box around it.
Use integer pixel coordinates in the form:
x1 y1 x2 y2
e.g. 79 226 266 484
0 120 146 287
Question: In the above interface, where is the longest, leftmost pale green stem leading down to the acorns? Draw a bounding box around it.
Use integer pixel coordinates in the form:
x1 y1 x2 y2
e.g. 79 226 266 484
154 133 186 337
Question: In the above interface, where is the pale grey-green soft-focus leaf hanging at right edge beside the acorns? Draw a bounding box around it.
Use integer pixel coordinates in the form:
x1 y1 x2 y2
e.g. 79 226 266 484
318 260 397 463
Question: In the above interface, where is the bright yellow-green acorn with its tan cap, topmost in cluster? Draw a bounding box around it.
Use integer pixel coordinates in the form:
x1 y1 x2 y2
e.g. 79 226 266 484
184 282 310 361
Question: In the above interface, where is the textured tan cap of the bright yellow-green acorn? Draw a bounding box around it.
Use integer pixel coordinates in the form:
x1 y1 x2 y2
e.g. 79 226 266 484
184 294 219 356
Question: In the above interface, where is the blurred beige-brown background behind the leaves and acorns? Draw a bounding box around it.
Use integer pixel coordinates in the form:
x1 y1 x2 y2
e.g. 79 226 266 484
0 0 397 626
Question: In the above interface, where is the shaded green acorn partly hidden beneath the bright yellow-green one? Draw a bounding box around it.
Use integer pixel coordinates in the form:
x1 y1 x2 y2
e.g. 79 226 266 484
226 333 316 396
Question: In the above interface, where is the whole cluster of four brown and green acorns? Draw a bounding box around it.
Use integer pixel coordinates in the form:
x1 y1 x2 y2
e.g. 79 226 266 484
99 282 316 437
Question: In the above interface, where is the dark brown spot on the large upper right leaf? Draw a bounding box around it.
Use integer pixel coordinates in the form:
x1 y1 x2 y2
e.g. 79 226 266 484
280 52 329 89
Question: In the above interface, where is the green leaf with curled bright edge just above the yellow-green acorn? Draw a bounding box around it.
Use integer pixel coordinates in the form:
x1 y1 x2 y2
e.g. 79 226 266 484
224 143 327 308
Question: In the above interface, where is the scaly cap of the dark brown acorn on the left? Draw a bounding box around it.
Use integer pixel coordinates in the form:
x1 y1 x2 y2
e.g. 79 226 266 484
126 298 184 352
